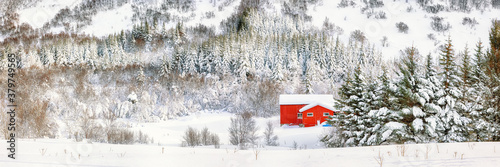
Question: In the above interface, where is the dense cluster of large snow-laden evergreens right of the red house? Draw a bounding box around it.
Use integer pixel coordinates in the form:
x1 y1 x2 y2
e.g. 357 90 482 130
322 20 500 147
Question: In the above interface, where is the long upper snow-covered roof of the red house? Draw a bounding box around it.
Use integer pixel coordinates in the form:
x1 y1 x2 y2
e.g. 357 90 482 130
280 94 335 106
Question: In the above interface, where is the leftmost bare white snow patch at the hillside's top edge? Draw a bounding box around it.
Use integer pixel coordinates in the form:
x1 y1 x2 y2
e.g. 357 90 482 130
18 0 82 29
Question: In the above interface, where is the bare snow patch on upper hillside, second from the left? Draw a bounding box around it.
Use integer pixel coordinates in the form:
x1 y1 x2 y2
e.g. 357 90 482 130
82 3 134 37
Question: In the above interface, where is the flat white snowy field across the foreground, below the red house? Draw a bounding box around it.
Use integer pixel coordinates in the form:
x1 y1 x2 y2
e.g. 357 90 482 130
0 113 500 167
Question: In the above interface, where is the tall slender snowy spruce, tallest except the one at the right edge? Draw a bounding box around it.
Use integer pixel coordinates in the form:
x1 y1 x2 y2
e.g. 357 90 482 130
438 37 470 142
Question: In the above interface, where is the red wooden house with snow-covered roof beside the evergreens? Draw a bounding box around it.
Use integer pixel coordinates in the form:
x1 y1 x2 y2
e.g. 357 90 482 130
280 95 339 127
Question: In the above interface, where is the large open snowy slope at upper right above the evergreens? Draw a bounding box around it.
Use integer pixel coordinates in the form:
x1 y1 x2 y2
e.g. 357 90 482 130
308 0 500 59
